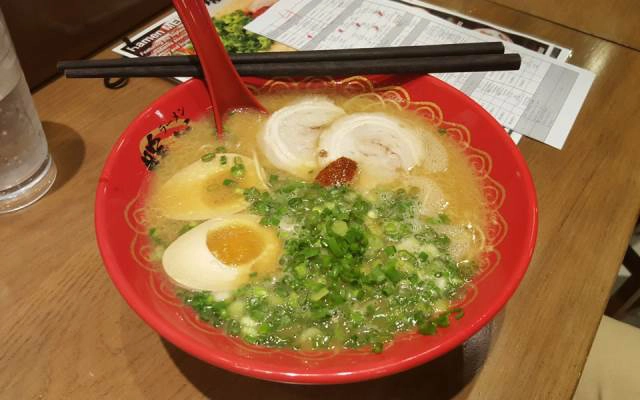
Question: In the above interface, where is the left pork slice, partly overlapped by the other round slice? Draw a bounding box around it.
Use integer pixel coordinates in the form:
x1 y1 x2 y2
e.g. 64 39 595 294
258 97 345 179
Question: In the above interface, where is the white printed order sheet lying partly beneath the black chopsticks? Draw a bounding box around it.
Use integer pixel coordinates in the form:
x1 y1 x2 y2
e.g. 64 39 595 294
245 0 594 149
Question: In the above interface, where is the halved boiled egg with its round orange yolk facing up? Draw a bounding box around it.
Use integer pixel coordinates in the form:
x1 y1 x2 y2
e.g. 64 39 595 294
162 214 282 299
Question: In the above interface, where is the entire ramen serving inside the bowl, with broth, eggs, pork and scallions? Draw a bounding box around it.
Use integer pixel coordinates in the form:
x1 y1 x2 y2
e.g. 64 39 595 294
146 92 487 352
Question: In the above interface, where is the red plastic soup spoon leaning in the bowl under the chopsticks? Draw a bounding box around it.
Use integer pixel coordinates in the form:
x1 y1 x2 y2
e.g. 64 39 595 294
173 0 265 138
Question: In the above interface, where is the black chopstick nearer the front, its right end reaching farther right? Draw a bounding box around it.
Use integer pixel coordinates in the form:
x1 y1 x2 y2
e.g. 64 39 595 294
64 54 521 78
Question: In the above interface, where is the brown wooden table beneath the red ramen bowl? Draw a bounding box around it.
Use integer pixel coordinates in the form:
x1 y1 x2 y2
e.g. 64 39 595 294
0 0 640 400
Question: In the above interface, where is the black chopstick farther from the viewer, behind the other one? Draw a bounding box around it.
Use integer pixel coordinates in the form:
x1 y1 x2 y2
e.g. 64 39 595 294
57 42 504 72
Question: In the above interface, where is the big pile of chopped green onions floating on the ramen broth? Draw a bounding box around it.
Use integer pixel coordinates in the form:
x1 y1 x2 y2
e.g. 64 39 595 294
178 182 468 352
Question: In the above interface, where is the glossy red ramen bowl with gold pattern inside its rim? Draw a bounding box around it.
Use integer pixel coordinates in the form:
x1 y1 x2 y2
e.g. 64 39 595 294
95 76 537 384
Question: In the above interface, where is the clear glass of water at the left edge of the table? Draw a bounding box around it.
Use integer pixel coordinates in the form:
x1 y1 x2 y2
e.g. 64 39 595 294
0 10 56 214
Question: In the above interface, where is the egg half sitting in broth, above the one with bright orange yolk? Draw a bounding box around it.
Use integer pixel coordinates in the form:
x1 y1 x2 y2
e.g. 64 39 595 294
154 153 265 221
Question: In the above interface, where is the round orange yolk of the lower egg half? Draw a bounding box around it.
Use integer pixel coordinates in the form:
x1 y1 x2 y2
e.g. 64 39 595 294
207 225 265 266
